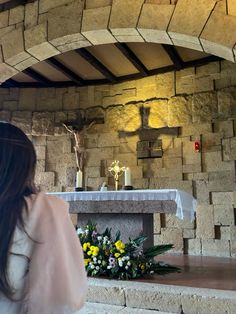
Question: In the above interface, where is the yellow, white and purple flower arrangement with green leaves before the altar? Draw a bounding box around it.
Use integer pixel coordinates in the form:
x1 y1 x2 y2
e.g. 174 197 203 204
77 222 180 279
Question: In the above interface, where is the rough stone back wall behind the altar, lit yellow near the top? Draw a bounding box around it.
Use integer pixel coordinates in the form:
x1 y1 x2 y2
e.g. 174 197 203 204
0 61 236 257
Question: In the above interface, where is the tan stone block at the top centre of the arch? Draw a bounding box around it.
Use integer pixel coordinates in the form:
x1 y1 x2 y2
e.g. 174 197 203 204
109 0 143 41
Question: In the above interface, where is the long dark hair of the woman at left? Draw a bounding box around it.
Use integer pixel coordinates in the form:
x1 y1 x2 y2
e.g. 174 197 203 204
0 121 36 299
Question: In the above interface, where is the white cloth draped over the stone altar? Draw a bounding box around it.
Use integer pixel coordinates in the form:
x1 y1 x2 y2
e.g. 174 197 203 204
48 189 197 221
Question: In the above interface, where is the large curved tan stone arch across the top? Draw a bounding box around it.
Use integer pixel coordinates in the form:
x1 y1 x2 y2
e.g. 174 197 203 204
0 0 236 83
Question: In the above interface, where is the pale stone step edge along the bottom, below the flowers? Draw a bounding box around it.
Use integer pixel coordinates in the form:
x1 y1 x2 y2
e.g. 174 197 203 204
88 274 236 314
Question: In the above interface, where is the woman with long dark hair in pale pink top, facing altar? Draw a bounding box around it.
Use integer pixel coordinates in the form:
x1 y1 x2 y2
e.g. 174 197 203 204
0 122 86 314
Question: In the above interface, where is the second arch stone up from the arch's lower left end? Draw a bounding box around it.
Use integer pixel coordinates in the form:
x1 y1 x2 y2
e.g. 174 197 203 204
1 28 31 66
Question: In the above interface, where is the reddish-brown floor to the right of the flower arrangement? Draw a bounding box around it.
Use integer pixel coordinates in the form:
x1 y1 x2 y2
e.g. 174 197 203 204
139 255 236 291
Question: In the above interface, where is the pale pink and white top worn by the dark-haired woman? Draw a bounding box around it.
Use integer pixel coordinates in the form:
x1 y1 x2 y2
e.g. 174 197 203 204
0 192 87 314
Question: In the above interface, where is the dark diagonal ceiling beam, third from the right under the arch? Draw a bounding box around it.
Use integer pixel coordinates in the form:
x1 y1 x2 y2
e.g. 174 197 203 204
75 48 118 83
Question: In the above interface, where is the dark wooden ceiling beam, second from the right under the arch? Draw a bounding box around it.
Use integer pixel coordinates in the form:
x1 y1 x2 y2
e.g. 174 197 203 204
115 43 149 77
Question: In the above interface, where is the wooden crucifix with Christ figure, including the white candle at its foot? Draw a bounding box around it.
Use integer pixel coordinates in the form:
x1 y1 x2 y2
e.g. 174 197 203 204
62 118 104 190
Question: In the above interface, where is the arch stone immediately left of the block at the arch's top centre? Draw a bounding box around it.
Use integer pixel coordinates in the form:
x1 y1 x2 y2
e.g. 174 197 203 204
81 6 116 45
